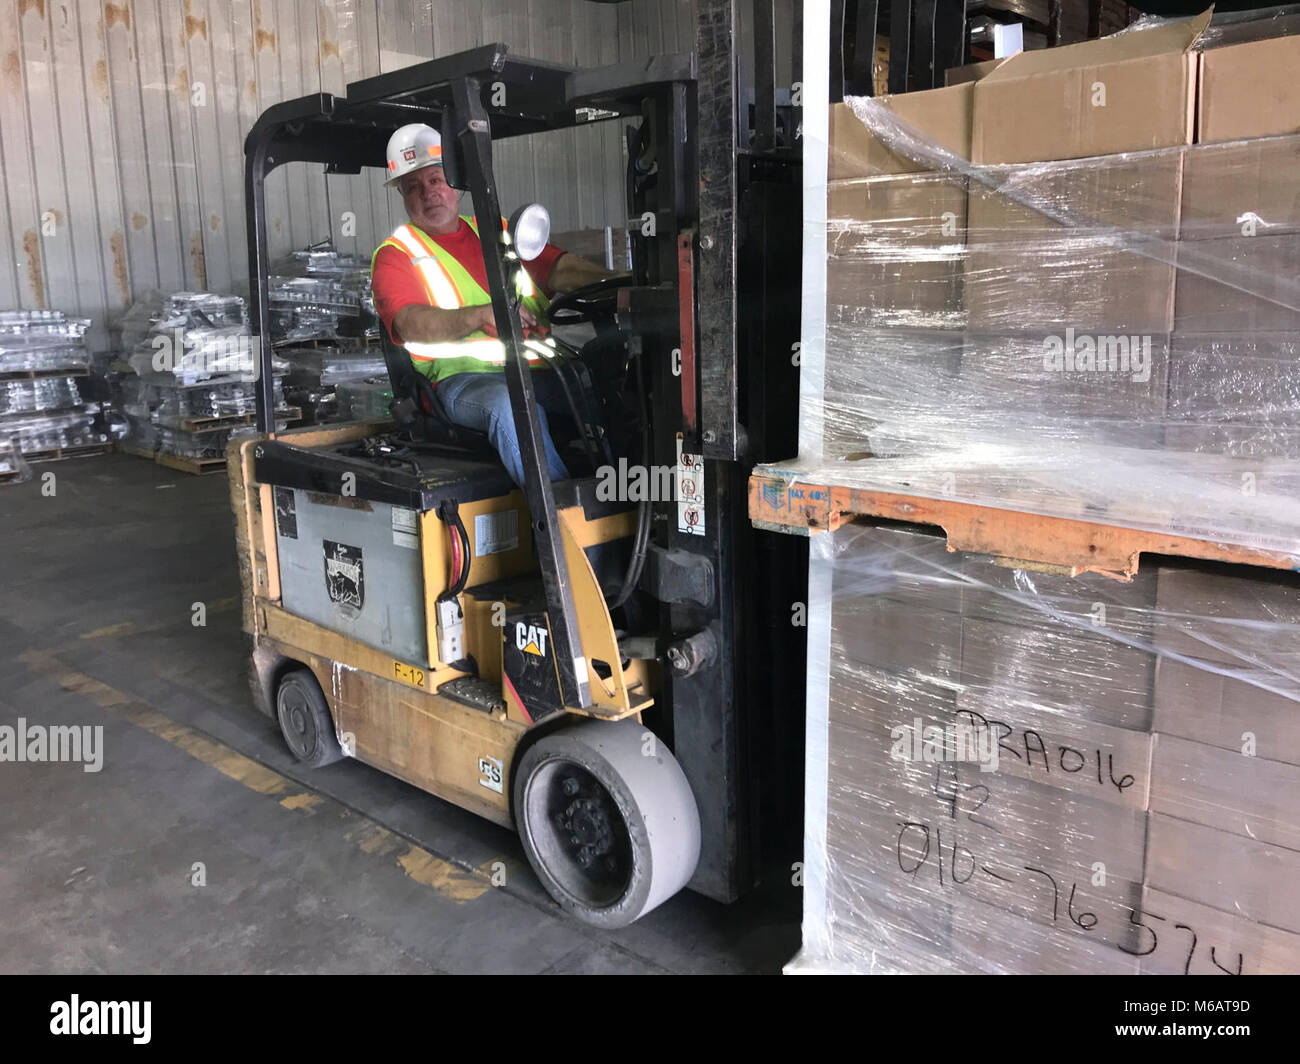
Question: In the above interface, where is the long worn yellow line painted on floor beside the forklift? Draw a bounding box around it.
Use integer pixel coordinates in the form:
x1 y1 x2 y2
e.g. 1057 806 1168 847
18 650 491 904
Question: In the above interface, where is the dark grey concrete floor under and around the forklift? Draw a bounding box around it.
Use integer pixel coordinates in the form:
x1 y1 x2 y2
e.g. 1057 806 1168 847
0 455 800 973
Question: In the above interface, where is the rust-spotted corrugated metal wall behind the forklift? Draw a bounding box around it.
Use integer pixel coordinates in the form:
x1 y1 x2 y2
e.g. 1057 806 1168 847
0 0 696 347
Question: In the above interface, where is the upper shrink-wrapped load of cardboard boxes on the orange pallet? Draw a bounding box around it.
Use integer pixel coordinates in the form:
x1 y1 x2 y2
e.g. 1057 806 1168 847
800 8 1300 553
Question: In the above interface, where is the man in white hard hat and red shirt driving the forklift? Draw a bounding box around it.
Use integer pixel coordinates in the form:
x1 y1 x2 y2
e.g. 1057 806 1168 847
371 122 620 486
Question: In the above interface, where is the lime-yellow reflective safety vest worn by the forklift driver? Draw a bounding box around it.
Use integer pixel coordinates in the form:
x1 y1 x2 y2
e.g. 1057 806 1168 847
371 215 549 381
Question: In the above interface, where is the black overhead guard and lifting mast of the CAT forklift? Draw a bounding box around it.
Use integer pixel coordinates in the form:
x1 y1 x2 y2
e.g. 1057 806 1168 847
244 0 806 901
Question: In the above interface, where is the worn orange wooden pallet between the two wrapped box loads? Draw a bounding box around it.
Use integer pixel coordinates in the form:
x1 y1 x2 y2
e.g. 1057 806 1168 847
749 466 1300 580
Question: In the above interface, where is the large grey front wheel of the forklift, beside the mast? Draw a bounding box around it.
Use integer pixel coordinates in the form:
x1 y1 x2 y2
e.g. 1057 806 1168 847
514 721 699 927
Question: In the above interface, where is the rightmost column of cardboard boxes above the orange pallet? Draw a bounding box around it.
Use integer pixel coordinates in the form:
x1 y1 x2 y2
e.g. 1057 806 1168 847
1169 36 1300 471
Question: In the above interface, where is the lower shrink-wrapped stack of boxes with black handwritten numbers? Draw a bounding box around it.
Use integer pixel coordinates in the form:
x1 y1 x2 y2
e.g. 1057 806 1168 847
798 525 1300 973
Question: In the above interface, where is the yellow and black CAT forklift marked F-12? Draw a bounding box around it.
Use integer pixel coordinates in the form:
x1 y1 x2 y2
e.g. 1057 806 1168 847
229 0 806 927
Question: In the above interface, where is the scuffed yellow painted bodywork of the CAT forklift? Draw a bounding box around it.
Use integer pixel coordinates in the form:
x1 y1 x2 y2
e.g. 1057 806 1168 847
229 423 653 826
